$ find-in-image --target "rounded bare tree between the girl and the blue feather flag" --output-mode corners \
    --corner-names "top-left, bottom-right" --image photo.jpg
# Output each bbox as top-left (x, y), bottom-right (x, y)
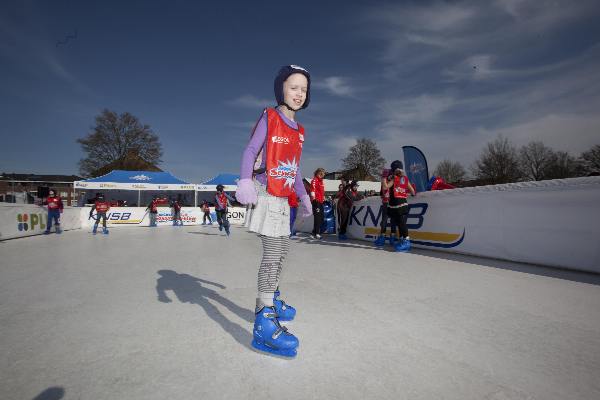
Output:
top-left (342, 138), bottom-right (385, 180)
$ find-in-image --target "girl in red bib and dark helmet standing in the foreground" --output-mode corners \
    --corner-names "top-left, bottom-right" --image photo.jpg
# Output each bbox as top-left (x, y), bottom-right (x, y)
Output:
top-left (236, 65), bottom-right (312, 357)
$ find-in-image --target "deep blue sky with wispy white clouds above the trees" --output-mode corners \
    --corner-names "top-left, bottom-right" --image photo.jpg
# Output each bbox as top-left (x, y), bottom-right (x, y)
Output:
top-left (0, 0), bottom-right (600, 182)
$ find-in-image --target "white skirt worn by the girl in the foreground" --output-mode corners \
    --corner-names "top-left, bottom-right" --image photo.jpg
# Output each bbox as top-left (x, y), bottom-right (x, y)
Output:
top-left (248, 181), bottom-right (290, 237)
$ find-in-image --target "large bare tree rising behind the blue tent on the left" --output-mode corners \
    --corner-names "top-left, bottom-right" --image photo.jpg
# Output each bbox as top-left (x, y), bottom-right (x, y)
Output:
top-left (77, 109), bottom-right (162, 176)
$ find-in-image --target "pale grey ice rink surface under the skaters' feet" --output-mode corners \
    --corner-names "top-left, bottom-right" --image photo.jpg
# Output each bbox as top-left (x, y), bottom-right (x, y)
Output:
top-left (0, 226), bottom-right (600, 400)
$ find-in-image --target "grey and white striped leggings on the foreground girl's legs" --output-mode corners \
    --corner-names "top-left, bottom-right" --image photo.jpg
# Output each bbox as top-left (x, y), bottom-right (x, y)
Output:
top-left (258, 235), bottom-right (290, 299)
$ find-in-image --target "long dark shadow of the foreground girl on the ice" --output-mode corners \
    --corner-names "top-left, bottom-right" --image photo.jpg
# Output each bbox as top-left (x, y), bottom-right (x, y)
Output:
top-left (156, 269), bottom-right (254, 349)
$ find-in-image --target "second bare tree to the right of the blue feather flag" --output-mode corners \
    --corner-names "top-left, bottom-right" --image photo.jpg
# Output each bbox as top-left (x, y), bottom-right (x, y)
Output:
top-left (471, 136), bottom-right (521, 184)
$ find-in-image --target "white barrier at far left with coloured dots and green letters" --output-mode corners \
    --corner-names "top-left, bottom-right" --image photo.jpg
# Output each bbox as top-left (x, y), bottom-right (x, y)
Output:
top-left (0, 203), bottom-right (81, 240)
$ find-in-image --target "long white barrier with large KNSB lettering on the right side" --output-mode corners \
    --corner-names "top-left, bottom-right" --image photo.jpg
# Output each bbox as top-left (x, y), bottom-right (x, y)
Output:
top-left (297, 177), bottom-right (600, 273)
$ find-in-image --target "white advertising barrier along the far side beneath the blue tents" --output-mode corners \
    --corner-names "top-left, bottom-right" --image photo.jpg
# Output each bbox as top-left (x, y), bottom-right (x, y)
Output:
top-left (80, 206), bottom-right (246, 228)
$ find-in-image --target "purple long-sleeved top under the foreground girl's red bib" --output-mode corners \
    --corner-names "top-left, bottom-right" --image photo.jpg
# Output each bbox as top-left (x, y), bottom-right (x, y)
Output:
top-left (240, 110), bottom-right (306, 198)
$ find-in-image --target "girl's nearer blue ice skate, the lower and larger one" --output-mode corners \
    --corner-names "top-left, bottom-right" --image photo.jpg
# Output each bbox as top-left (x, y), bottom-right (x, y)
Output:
top-left (252, 307), bottom-right (299, 358)
